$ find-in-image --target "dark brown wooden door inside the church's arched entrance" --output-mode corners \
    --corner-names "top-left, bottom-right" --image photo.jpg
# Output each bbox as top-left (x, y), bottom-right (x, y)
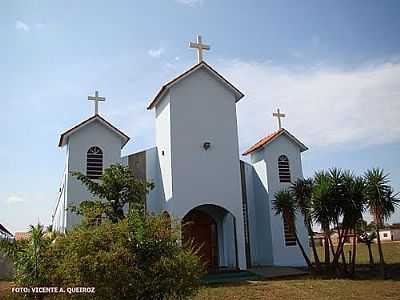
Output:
top-left (183, 210), bottom-right (218, 268)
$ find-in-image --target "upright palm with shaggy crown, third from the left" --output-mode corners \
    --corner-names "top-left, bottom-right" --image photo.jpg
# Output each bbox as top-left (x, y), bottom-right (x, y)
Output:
top-left (311, 171), bottom-right (334, 265)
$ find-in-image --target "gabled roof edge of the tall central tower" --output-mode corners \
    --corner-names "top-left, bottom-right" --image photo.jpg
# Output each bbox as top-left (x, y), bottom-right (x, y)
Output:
top-left (147, 61), bottom-right (244, 109)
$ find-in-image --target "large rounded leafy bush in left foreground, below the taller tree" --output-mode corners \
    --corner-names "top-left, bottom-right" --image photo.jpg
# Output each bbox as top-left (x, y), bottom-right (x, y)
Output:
top-left (47, 211), bottom-right (203, 299)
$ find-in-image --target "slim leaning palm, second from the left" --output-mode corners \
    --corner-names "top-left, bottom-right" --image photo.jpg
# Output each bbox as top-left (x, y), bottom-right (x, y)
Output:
top-left (290, 178), bottom-right (321, 271)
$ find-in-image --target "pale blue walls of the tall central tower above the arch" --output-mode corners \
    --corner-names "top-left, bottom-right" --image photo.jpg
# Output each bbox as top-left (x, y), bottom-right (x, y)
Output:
top-left (156, 69), bottom-right (246, 269)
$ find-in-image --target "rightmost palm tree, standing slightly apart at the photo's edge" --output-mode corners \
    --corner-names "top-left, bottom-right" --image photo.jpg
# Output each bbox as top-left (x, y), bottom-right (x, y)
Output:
top-left (364, 168), bottom-right (399, 279)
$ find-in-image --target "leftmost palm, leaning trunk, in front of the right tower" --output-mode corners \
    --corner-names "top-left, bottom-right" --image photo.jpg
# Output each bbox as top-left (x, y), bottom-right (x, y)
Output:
top-left (272, 190), bottom-right (314, 271)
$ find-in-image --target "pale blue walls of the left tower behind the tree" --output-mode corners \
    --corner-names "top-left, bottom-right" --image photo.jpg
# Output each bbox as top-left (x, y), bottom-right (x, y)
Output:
top-left (65, 121), bottom-right (122, 228)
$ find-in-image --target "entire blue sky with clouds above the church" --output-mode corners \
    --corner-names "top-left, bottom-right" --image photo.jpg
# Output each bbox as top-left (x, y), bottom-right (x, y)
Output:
top-left (0, 0), bottom-right (400, 231)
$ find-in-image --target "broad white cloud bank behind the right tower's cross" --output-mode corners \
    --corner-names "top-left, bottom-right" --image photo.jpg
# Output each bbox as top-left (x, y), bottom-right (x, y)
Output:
top-left (219, 61), bottom-right (400, 149)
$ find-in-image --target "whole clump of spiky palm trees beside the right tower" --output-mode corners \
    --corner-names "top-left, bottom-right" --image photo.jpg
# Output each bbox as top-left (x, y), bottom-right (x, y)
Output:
top-left (273, 168), bottom-right (399, 278)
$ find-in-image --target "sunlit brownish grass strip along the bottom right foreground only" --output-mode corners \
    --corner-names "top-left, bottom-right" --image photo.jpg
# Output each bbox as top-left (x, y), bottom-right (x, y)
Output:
top-left (195, 278), bottom-right (400, 300)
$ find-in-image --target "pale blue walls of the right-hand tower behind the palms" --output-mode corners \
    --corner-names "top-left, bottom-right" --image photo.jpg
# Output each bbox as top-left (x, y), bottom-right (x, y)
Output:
top-left (252, 135), bottom-right (309, 266)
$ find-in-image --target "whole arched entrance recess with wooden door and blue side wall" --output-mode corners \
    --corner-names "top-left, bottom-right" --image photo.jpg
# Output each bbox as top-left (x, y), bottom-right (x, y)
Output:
top-left (182, 204), bottom-right (238, 271)
